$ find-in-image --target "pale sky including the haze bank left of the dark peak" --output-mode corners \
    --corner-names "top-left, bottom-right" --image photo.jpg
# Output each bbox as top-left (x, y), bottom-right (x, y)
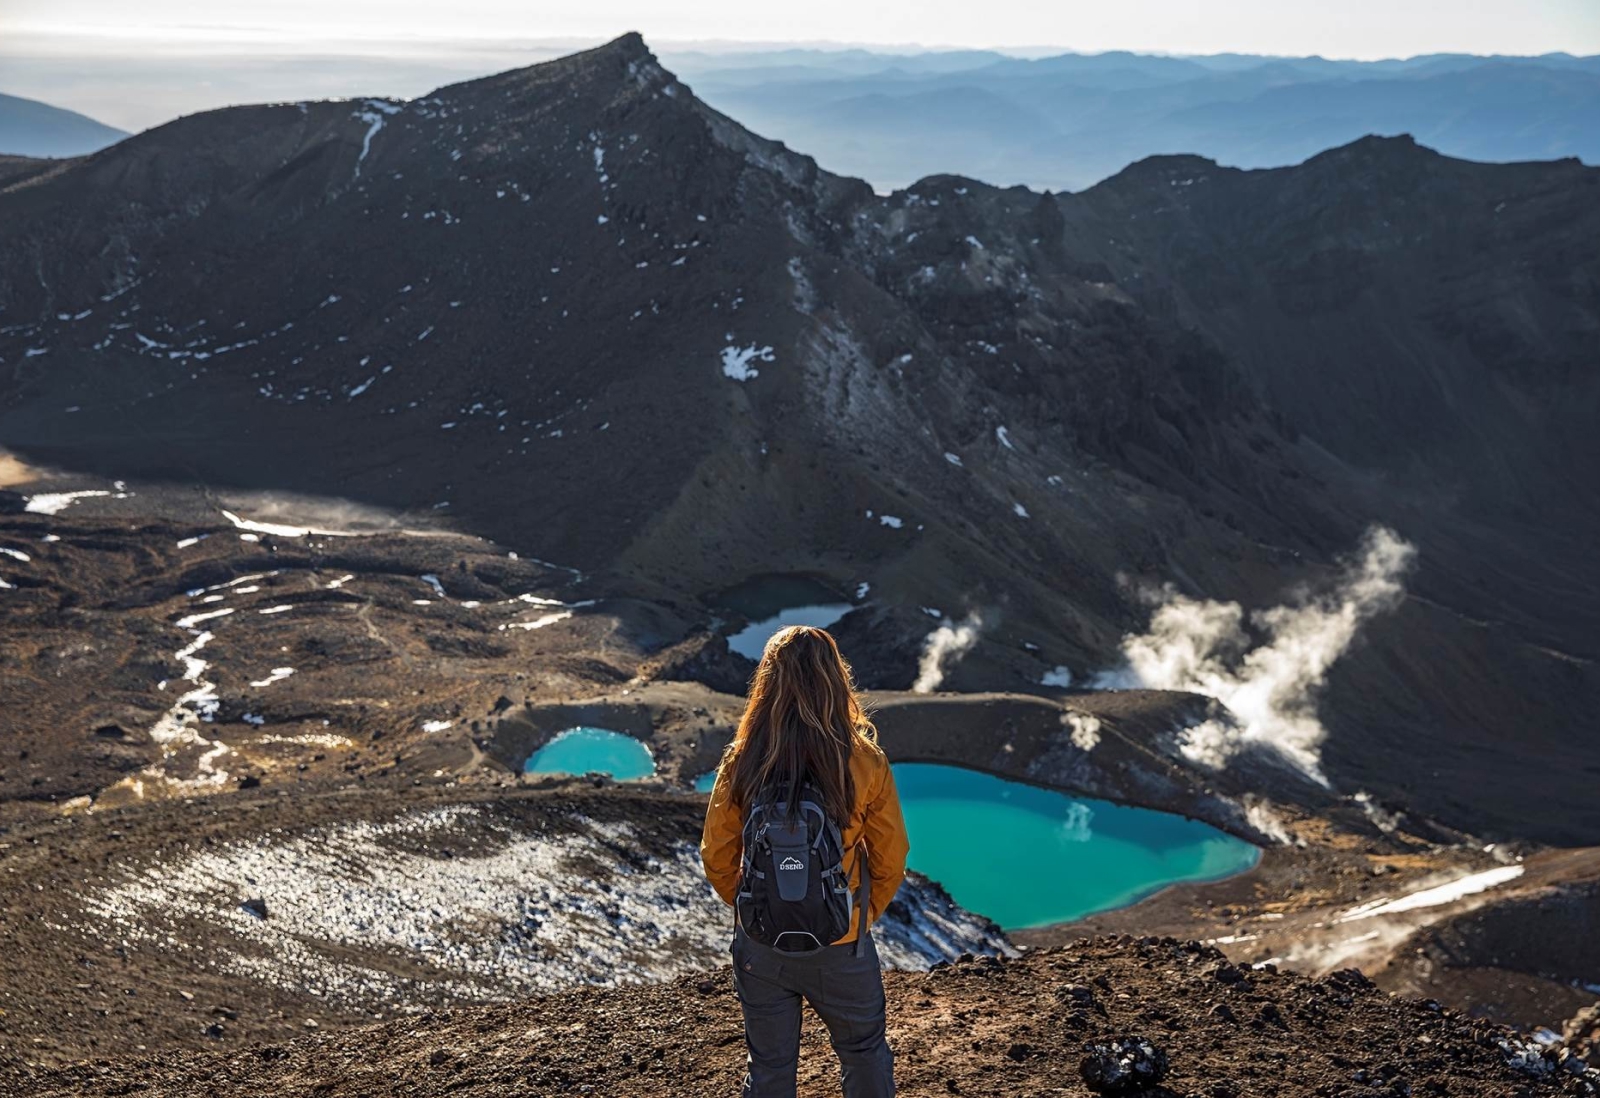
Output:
top-left (0, 0), bottom-right (1600, 128)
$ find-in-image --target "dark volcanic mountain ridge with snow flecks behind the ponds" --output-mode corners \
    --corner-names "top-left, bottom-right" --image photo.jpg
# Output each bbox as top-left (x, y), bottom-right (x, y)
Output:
top-left (0, 35), bottom-right (1600, 842)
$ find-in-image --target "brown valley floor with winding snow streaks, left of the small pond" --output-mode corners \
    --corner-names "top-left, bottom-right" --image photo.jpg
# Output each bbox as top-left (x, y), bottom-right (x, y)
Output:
top-left (0, 482), bottom-right (668, 811)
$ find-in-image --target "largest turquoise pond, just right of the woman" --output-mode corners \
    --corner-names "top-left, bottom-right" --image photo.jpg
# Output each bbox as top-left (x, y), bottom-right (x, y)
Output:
top-left (894, 762), bottom-right (1261, 930)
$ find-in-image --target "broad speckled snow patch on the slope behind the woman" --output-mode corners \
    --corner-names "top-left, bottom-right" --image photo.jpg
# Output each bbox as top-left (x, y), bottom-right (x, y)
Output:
top-left (78, 805), bottom-right (1016, 1015)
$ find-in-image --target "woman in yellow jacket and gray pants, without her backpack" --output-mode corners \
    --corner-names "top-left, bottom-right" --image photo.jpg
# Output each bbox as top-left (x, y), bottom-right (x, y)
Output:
top-left (701, 626), bottom-right (909, 1098)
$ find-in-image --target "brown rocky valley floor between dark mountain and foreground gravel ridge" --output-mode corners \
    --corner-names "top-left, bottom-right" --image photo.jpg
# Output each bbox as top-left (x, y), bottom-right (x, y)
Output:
top-left (0, 483), bottom-right (1600, 1066)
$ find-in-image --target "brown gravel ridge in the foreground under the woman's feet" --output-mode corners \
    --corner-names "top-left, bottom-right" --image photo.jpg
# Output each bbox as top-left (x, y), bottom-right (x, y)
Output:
top-left (0, 936), bottom-right (1600, 1098)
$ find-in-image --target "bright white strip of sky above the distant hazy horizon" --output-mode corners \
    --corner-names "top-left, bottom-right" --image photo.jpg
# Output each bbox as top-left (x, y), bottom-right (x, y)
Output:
top-left (15, 0), bottom-right (1600, 58)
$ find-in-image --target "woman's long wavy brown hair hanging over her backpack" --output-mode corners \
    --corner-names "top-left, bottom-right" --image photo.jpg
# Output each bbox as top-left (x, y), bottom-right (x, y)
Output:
top-left (722, 626), bottom-right (878, 828)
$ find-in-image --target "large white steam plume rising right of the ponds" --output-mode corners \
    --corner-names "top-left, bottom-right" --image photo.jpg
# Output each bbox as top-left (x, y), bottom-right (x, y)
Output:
top-left (1101, 527), bottom-right (1416, 786)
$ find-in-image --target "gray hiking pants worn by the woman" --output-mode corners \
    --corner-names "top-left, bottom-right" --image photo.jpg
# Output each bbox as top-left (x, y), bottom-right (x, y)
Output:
top-left (733, 928), bottom-right (894, 1098)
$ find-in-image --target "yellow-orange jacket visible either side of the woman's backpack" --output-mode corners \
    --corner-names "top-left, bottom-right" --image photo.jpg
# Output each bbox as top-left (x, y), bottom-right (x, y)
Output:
top-left (701, 744), bottom-right (910, 946)
